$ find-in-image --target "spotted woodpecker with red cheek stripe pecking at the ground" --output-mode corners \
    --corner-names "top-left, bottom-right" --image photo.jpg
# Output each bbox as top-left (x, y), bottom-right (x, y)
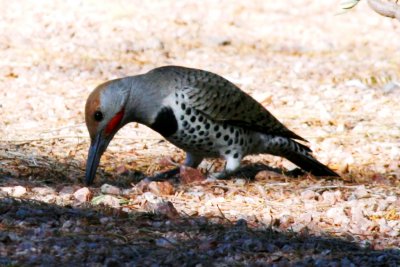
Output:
top-left (85, 66), bottom-right (339, 185)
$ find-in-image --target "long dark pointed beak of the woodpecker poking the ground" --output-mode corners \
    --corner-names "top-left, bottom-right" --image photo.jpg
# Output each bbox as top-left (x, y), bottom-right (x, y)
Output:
top-left (85, 132), bottom-right (112, 185)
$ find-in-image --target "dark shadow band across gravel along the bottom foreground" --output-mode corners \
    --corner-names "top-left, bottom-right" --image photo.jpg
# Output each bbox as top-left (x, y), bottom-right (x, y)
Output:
top-left (0, 198), bottom-right (400, 266)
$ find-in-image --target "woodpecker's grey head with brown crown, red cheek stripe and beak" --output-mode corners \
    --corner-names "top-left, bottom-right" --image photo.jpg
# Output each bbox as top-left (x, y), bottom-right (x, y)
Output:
top-left (85, 79), bottom-right (129, 185)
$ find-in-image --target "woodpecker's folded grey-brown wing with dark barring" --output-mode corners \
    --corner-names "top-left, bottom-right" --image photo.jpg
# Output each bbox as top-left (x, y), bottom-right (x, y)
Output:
top-left (176, 71), bottom-right (306, 141)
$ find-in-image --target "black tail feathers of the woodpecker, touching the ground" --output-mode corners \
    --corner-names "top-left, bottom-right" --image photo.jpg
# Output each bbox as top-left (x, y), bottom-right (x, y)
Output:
top-left (285, 152), bottom-right (340, 177)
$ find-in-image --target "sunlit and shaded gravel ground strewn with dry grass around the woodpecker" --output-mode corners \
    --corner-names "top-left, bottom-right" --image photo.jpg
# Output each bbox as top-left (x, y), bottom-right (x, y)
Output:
top-left (0, 0), bottom-right (400, 266)
